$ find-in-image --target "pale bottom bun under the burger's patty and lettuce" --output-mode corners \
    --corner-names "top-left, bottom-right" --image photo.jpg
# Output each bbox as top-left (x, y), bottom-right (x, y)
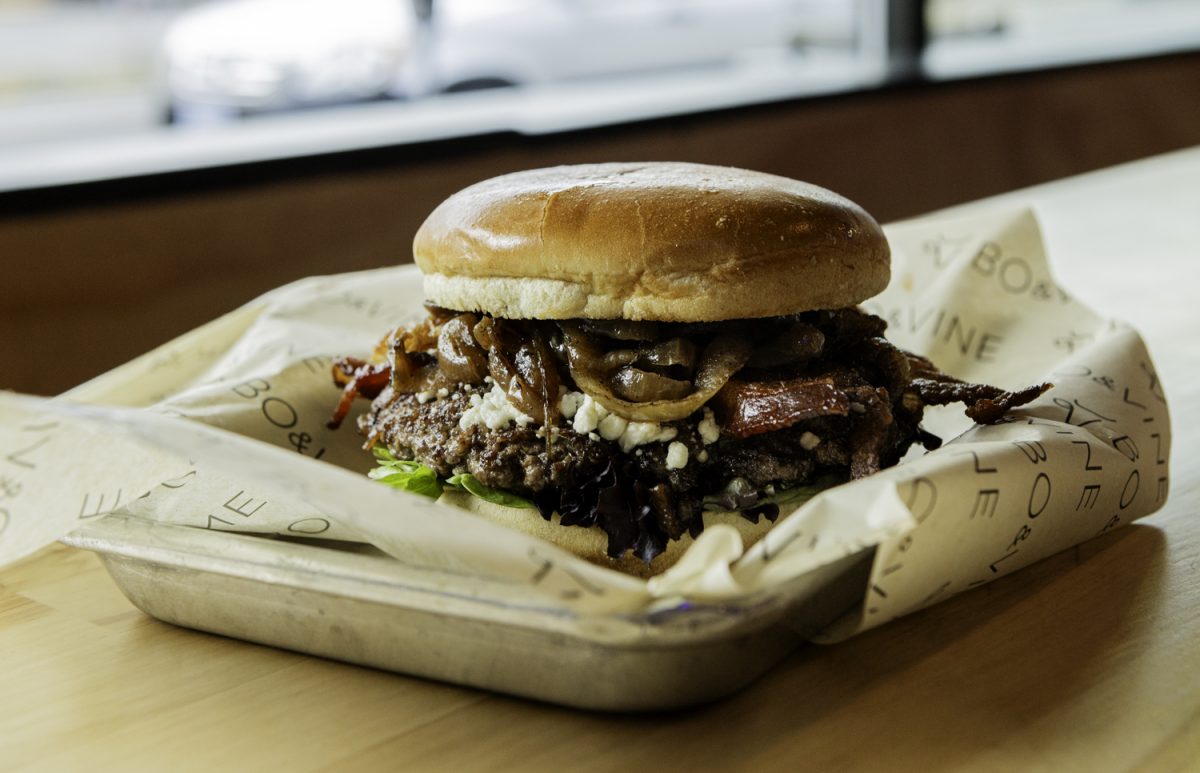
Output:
top-left (439, 491), bottom-right (796, 577)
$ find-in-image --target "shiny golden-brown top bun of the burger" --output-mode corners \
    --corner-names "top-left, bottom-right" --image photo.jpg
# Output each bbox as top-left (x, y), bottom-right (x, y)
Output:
top-left (413, 162), bottom-right (890, 322)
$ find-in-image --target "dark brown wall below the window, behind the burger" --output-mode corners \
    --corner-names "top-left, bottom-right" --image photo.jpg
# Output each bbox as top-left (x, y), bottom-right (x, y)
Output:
top-left (0, 55), bottom-right (1200, 394)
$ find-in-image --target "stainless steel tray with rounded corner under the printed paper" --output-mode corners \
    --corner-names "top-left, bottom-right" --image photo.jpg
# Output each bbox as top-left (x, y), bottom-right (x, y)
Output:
top-left (64, 515), bottom-right (871, 711)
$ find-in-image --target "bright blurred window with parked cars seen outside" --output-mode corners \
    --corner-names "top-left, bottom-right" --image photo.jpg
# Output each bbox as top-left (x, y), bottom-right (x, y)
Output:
top-left (0, 0), bottom-right (1200, 191)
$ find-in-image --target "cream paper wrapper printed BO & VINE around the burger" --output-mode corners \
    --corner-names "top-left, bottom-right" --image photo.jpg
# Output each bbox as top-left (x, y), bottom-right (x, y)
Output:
top-left (0, 206), bottom-right (1170, 641)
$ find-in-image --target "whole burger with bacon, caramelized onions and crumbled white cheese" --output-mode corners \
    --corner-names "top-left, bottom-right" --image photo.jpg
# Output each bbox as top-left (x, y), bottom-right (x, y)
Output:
top-left (331, 162), bottom-right (1048, 576)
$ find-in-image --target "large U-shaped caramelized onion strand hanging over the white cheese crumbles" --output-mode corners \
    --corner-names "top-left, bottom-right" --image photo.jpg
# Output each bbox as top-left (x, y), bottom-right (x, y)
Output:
top-left (562, 323), bottom-right (750, 421)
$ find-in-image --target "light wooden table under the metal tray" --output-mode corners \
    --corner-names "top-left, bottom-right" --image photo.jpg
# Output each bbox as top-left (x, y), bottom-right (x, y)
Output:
top-left (0, 149), bottom-right (1200, 771)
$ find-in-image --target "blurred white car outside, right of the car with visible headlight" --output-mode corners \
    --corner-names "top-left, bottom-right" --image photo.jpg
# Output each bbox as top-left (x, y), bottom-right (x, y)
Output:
top-left (397, 0), bottom-right (857, 95)
